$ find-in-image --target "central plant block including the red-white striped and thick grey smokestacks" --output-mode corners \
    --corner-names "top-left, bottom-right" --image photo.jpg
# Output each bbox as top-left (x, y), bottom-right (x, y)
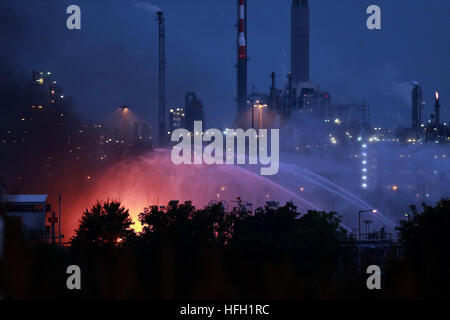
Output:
top-left (230, 0), bottom-right (370, 135)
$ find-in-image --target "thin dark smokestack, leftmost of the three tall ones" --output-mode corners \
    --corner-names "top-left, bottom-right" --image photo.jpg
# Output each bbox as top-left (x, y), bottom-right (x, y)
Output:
top-left (156, 11), bottom-right (167, 146)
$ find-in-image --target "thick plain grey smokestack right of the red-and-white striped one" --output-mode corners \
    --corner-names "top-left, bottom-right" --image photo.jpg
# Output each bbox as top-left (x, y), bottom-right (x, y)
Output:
top-left (291, 0), bottom-right (309, 86)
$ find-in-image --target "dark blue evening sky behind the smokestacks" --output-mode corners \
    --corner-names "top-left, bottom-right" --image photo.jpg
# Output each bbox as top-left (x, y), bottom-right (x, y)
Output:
top-left (4, 0), bottom-right (450, 126)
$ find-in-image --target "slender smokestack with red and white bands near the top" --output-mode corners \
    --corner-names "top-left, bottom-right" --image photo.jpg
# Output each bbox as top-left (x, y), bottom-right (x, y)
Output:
top-left (237, 0), bottom-right (247, 117)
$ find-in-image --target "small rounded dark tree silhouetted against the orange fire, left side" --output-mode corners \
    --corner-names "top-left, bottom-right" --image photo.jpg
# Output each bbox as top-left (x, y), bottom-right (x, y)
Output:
top-left (71, 201), bottom-right (135, 247)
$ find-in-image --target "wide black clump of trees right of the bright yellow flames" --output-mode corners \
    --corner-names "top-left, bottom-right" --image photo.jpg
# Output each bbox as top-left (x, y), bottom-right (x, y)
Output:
top-left (134, 202), bottom-right (354, 298)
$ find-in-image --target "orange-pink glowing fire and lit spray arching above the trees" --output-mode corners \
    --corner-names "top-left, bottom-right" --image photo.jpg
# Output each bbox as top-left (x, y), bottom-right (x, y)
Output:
top-left (58, 151), bottom-right (298, 239)
